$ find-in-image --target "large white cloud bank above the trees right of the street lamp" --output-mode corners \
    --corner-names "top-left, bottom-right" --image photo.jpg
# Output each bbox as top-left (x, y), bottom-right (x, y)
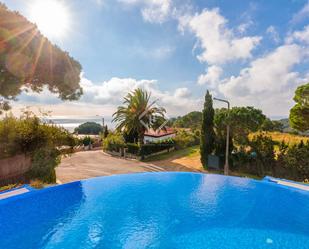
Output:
top-left (219, 44), bottom-right (303, 115)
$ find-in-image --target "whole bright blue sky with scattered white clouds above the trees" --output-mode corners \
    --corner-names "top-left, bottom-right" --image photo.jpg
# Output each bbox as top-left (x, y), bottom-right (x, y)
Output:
top-left (1, 0), bottom-right (309, 118)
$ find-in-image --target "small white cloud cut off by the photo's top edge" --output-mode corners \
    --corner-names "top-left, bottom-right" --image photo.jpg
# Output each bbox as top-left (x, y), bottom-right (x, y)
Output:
top-left (118, 0), bottom-right (172, 23)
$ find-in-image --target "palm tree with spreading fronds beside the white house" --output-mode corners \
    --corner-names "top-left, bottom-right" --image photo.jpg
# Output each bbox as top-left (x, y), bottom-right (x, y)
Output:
top-left (112, 88), bottom-right (166, 144)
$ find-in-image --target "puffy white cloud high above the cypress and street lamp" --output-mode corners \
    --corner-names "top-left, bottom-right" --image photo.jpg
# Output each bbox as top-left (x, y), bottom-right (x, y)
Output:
top-left (179, 8), bottom-right (262, 64)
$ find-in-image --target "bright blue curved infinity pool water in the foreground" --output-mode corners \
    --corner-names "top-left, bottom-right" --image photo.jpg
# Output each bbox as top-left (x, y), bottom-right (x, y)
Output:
top-left (0, 173), bottom-right (309, 249)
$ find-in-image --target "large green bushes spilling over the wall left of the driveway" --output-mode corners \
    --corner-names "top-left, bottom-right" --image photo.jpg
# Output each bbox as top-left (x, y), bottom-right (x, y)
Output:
top-left (0, 112), bottom-right (75, 182)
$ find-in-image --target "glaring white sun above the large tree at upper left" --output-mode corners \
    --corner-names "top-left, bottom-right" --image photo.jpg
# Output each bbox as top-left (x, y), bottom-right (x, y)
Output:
top-left (29, 0), bottom-right (70, 38)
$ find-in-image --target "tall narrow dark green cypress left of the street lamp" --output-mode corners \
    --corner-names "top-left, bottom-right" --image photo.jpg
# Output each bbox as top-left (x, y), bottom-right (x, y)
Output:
top-left (200, 91), bottom-right (215, 168)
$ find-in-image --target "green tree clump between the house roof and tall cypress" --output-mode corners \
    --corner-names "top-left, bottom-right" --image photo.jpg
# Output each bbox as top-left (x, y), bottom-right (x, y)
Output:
top-left (169, 111), bottom-right (202, 130)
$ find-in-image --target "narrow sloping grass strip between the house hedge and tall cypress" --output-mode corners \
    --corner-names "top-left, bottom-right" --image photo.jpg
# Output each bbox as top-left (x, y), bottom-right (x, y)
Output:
top-left (143, 145), bottom-right (200, 162)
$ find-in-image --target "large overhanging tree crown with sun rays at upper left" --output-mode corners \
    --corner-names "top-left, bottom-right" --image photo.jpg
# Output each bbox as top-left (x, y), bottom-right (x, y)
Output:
top-left (0, 3), bottom-right (82, 111)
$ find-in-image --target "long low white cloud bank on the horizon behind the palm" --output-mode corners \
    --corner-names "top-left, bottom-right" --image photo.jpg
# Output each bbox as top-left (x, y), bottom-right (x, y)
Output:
top-left (13, 75), bottom-right (201, 116)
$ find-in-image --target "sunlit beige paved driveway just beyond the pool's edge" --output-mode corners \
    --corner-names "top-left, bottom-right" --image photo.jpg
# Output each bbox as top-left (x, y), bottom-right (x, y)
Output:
top-left (56, 151), bottom-right (200, 183)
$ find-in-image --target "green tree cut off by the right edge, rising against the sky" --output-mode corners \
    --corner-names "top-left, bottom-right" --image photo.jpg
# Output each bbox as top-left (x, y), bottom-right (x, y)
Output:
top-left (289, 83), bottom-right (309, 131)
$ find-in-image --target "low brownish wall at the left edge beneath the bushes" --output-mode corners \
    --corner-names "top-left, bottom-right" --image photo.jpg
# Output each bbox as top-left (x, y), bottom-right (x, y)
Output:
top-left (0, 155), bottom-right (31, 186)
